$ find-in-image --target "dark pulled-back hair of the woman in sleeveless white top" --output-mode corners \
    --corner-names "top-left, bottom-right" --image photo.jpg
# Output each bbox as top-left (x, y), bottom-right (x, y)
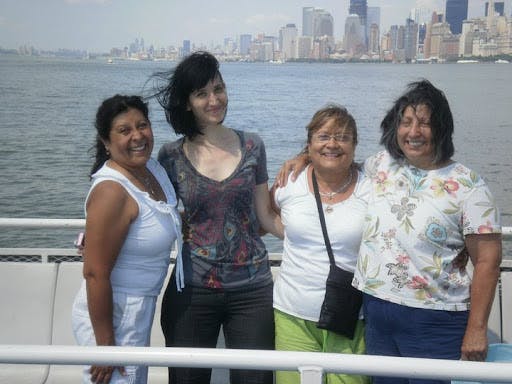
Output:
top-left (89, 95), bottom-right (149, 177)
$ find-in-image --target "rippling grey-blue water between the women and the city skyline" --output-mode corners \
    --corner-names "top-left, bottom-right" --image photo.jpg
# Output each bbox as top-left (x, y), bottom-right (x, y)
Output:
top-left (0, 56), bottom-right (512, 255)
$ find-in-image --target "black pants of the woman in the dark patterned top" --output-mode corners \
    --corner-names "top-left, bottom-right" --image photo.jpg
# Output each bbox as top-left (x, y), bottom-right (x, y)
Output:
top-left (160, 274), bottom-right (274, 384)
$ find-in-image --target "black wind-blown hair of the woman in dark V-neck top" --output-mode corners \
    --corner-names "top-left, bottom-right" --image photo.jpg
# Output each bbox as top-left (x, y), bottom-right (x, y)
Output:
top-left (152, 51), bottom-right (224, 139)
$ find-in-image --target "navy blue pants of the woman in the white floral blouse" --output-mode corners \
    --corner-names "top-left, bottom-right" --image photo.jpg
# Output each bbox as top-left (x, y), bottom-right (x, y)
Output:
top-left (363, 294), bottom-right (469, 384)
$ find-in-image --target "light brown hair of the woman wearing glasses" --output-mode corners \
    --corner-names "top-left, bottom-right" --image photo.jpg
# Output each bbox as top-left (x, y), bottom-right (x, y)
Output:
top-left (306, 103), bottom-right (357, 145)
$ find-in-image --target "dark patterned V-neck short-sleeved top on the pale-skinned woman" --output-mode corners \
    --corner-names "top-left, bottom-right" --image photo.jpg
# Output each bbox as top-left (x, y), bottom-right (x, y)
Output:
top-left (158, 130), bottom-right (272, 290)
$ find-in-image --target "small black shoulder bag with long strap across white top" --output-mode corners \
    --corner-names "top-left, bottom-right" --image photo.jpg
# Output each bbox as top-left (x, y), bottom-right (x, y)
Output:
top-left (311, 170), bottom-right (363, 339)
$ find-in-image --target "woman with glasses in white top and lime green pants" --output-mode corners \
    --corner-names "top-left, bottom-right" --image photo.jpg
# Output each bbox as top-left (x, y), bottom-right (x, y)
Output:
top-left (274, 105), bottom-right (369, 384)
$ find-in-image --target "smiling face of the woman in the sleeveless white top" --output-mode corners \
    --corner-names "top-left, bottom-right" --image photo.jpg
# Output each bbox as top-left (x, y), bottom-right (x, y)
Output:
top-left (105, 108), bottom-right (154, 169)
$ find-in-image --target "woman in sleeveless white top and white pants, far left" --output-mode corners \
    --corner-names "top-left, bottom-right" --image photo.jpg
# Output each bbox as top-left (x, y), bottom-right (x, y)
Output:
top-left (72, 95), bottom-right (181, 384)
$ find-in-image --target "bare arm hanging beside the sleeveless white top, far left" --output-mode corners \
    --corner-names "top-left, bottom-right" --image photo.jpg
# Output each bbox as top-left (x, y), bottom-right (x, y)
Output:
top-left (84, 181), bottom-right (138, 383)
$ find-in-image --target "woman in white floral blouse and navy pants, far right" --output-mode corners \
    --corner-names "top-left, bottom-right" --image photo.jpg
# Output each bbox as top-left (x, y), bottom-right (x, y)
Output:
top-left (354, 80), bottom-right (501, 384)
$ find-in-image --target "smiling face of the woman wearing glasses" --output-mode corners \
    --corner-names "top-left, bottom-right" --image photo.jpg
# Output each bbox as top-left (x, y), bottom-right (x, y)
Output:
top-left (308, 118), bottom-right (356, 172)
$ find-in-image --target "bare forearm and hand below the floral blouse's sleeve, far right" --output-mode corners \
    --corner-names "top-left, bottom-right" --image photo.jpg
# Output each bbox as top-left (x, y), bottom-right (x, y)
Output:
top-left (461, 234), bottom-right (501, 361)
